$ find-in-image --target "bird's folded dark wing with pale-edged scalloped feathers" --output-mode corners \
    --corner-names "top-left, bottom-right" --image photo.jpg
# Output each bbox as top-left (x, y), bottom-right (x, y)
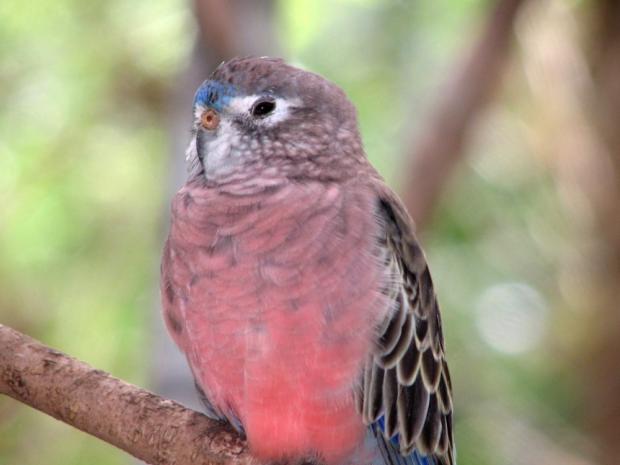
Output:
top-left (358, 188), bottom-right (455, 465)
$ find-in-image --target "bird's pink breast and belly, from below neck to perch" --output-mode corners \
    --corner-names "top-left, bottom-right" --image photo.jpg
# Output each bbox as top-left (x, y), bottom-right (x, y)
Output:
top-left (162, 180), bottom-right (386, 463)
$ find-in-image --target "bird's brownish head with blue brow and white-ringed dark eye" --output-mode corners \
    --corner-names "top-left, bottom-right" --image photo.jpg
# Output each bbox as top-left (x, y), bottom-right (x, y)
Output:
top-left (187, 57), bottom-right (364, 185)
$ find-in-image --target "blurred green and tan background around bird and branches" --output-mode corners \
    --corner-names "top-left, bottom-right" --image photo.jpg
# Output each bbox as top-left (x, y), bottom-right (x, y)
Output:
top-left (0, 0), bottom-right (620, 465)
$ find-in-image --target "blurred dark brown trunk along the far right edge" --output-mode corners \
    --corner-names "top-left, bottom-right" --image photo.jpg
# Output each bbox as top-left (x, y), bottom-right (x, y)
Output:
top-left (586, 0), bottom-right (620, 465)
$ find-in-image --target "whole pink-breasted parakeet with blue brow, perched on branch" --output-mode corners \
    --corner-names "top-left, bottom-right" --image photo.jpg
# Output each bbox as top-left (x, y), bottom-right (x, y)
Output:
top-left (160, 57), bottom-right (456, 465)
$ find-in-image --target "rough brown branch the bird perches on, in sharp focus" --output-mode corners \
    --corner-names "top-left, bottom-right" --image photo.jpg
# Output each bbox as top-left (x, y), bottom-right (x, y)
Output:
top-left (0, 325), bottom-right (255, 465)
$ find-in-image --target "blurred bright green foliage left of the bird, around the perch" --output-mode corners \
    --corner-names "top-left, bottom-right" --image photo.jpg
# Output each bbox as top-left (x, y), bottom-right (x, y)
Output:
top-left (0, 0), bottom-right (192, 464)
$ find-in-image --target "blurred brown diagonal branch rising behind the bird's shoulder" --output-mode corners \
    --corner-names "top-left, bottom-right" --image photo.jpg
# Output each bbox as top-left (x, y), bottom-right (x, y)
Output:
top-left (402, 0), bottom-right (525, 226)
